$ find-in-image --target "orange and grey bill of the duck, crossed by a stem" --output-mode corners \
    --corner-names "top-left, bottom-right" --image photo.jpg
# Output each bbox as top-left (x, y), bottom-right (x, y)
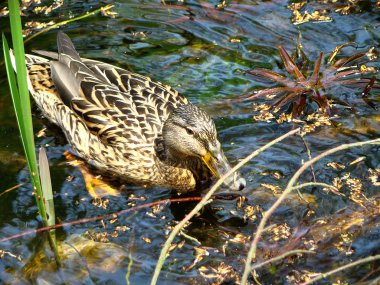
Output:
top-left (202, 150), bottom-right (246, 190)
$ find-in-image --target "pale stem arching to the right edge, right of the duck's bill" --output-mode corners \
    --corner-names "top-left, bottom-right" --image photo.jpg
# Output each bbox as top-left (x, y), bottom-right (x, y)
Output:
top-left (241, 139), bottom-right (380, 285)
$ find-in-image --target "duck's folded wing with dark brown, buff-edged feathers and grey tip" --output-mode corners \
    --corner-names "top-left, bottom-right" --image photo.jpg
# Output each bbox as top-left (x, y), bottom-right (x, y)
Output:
top-left (51, 33), bottom-right (187, 147)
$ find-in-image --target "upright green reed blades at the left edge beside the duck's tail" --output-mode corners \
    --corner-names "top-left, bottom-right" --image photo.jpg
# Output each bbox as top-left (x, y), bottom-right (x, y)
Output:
top-left (2, 1), bottom-right (57, 246)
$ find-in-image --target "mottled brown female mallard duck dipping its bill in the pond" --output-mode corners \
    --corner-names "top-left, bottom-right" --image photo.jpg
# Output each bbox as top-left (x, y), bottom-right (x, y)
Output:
top-left (26, 32), bottom-right (245, 192)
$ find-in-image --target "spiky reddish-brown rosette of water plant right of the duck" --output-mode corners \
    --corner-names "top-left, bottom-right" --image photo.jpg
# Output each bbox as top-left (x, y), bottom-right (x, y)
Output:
top-left (245, 44), bottom-right (380, 118)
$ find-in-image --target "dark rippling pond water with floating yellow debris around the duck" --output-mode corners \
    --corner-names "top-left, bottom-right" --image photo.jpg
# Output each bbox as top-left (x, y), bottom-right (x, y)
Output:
top-left (0, 0), bottom-right (380, 284)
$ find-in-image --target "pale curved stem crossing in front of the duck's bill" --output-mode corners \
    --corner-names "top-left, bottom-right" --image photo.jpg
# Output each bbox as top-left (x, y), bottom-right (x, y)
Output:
top-left (150, 128), bottom-right (300, 285)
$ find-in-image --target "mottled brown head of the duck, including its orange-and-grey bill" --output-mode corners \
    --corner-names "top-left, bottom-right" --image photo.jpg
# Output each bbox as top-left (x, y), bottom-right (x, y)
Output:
top-left (162, 104), bottom-right (246, 190)
